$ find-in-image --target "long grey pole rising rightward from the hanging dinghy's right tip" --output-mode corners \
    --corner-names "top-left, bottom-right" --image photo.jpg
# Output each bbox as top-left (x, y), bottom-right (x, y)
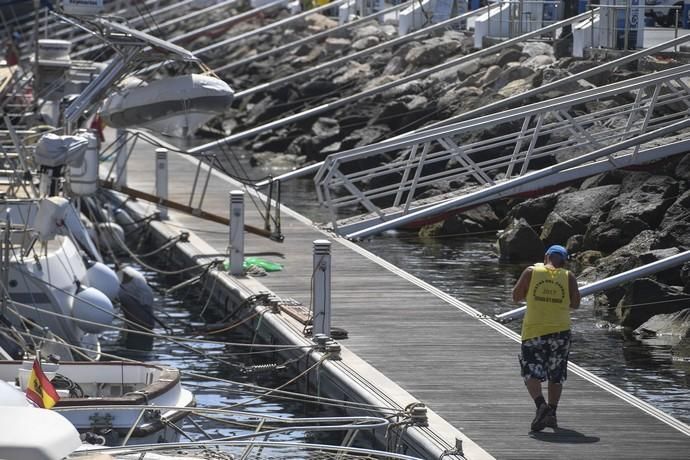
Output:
top-left (235, 6), bottom-right (488, 99)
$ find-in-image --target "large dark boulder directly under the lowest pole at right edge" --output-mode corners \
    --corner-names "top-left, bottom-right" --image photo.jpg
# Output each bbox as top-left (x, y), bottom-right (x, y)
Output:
top-left (616, 278), bottom-right (690, 329)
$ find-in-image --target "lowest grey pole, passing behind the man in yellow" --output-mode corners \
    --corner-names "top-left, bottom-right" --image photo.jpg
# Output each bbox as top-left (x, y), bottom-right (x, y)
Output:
top-left (494, 251), bottom-right (690, 323)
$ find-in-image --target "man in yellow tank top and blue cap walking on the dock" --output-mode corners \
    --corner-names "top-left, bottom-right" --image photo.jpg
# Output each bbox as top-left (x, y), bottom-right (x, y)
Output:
top-left (513, 245), bottom-right (580, 431)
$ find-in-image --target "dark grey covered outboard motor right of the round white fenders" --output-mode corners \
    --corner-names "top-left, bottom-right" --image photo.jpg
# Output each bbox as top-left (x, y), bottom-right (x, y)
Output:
top-left (118, 267), bottom-right (155, 350)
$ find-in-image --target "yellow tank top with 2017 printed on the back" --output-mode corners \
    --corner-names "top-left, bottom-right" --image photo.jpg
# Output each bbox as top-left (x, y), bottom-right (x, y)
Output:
top-left (522, 264), bottom-right (570, 340)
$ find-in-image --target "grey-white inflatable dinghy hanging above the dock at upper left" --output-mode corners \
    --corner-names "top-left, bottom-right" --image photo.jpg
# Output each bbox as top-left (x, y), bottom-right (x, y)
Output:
top-left (100, 74), bottom-right (234, 137)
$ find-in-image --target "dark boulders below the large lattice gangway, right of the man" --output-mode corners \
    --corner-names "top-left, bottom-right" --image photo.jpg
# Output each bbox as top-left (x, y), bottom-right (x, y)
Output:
top-left (492, 154), bottom-right (690, 359)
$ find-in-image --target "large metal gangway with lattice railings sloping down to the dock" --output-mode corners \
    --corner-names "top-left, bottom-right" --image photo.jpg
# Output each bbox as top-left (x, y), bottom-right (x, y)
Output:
top-left (314, 65), bottom-right (690, 238)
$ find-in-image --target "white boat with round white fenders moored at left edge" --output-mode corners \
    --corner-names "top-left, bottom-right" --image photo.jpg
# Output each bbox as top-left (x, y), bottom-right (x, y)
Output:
top-left (0, 200), bottom-right (117, 359)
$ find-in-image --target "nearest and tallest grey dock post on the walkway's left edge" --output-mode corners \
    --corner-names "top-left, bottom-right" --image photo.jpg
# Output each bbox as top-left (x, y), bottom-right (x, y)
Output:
top-left (312, 240), bottom-right (331, 338)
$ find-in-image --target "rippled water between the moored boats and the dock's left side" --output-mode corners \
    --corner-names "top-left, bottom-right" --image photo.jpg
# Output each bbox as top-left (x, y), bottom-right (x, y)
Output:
top-left (102, 261), bottom-right (346, 450)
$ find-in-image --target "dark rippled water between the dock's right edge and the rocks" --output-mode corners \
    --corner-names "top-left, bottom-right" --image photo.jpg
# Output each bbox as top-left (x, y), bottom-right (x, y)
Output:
top-left (270, 175), bottom-right (690, 423)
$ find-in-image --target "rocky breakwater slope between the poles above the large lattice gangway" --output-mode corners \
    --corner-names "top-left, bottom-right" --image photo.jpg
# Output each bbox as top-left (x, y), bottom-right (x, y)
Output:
top-left (200, 14), bottom-right (608, 166)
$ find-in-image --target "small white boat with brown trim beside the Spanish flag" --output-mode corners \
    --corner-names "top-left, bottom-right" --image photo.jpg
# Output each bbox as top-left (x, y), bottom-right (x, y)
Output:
top-left (0, 361), bottom-right (195, 445)
